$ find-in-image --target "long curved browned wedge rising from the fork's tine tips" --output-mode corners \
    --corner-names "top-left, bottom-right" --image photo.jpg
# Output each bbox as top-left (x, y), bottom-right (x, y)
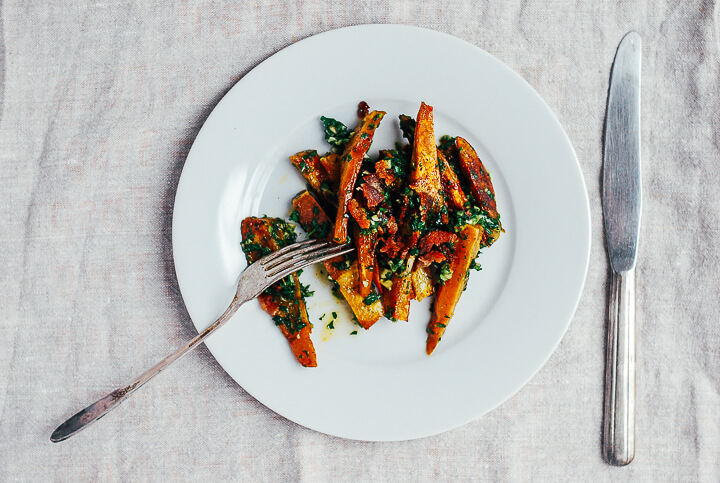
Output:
top-left (333, 111), bottom-right (385, 243)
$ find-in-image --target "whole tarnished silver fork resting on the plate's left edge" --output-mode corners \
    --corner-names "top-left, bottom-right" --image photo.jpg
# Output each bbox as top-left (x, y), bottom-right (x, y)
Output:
top-left (50, 240), bottom-right (353, 443)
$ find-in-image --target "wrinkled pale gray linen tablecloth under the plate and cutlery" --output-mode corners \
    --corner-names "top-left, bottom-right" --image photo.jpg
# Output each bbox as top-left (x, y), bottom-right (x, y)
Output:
top-left (0, 0), bottom-right (720, 481)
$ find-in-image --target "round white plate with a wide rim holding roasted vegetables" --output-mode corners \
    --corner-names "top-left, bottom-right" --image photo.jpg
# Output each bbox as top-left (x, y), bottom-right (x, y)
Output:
top-left (173, 25), bottom-right (590, 441)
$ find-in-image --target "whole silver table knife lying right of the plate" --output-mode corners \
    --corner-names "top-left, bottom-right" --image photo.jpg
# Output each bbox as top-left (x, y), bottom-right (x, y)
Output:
top-left (603, 32), bottom-right (642, 466)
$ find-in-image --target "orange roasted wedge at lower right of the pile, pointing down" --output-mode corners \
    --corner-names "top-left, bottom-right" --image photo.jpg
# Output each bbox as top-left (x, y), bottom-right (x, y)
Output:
top-left (425, 225), bottom-right (483, 355)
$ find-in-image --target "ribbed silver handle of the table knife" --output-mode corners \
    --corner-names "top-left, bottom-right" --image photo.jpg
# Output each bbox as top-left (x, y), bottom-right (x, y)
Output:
top-left (603, 268), bottom-right (635, 466)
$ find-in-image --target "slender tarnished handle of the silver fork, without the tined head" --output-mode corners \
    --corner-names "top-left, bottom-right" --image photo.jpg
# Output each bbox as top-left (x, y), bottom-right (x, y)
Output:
top-left (50, 294), bottom-right (245, 443)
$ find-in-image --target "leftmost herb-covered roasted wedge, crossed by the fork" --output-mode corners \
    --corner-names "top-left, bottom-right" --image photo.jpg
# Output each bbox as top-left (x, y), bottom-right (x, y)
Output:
top-left (241, 217), bottom-right (317, 367)
